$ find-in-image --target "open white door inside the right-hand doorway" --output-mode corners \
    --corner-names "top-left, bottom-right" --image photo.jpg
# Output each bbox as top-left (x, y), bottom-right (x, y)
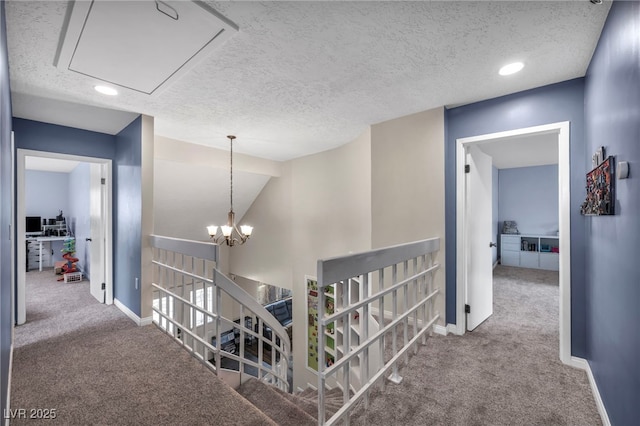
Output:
top-left (465, 145), bottom-right (493, 330)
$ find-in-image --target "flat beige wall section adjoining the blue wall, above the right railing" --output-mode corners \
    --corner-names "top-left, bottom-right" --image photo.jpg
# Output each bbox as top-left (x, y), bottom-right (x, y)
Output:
top-left (371, 108), bottom-right (445, 325)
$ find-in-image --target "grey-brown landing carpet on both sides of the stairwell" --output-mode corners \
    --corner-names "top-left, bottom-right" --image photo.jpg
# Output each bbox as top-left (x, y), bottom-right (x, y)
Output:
top-left (11, 266), bottom-right (601, 426)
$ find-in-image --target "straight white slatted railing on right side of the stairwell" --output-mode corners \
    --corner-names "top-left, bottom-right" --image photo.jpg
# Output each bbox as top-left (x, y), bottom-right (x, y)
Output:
top-left (318, 238), bottom-right (440, 425)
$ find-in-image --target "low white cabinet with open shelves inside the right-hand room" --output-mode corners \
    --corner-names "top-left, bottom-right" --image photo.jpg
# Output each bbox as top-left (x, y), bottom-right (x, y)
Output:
top-left (500, 234), bottom-right (560, 271)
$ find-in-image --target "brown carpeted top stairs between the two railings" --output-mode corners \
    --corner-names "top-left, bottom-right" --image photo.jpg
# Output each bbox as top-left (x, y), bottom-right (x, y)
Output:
top-left (238, 379), bottom-right (343, 426)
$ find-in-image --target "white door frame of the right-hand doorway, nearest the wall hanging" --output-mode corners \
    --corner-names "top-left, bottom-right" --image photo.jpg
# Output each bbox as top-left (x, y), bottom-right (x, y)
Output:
top-left (454, 121), bottom-right (571, 364)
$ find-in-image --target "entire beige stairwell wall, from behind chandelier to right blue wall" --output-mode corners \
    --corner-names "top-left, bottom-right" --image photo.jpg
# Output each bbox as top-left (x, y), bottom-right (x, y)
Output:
top-left (154, 108), bottom-right (445, 387)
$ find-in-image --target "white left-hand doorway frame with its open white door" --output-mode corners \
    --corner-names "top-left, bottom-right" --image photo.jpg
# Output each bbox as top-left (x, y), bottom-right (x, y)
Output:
top-left (15, 149), bottom-right (113, 325)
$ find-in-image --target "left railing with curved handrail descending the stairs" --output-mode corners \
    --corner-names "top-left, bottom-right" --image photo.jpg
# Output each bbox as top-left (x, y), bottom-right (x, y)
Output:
top-left (149, 234), bottom-right (291, 391)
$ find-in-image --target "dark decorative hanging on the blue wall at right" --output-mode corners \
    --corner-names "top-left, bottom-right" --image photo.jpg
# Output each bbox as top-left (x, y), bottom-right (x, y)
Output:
top-left (580, 156), bottom-right (616, 216)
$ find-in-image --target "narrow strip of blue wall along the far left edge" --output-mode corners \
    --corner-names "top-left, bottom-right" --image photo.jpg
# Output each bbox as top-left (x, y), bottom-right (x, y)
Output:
top-left (0, 1), bottom-right (13, 413)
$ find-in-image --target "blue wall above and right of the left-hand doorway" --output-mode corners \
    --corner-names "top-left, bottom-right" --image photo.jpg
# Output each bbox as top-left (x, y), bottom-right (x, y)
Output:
top-left (13, 117), bottom-right (142, 315)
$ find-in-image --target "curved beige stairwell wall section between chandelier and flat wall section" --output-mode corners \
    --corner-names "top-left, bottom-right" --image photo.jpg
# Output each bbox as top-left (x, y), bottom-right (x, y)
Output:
top-left (230, 130), bottom-right (371, 386)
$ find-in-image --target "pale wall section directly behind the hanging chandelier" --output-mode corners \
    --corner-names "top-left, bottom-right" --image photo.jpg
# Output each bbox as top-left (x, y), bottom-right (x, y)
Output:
top-left (153, 136), bottom-right (282, 273)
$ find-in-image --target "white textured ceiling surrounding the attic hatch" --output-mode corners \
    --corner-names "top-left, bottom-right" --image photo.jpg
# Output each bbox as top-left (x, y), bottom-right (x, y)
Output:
top-left (6, 0), bottom-right (610, 160)
